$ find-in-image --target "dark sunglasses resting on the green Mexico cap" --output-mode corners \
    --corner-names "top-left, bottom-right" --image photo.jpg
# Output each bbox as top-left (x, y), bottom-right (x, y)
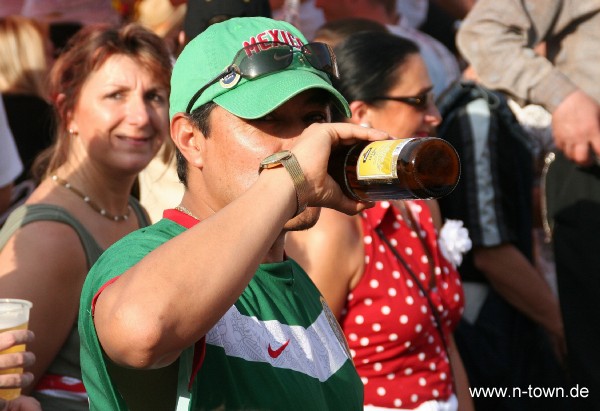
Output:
top-left (185, 41), bottom-right (339, 114)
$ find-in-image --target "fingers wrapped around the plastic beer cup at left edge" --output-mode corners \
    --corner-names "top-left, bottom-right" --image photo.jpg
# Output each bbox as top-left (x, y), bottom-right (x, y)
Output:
top-left (0, 330), bottom-right (42, 411)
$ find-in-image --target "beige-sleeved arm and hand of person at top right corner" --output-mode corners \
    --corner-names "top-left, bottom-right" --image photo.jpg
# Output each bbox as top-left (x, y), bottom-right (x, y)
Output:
top-left (456, 0), bottom-right (600, 165)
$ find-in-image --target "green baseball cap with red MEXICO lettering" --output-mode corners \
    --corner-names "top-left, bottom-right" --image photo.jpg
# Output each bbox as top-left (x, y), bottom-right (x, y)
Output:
top-left (169, 17), bottom-right (351, 119)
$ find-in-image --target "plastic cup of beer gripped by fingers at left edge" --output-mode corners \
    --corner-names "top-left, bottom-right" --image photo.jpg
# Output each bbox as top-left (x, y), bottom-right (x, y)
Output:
top-left (0, 298), bottom-right (32, 400)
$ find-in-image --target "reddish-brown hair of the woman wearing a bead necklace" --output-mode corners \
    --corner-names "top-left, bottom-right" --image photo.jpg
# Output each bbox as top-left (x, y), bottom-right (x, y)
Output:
top-left (33, 23), bottom-right (172, 180)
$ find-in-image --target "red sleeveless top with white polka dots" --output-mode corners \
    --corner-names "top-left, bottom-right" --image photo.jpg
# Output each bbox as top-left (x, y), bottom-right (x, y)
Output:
top-left (341, 200), bottom-right (463, 409)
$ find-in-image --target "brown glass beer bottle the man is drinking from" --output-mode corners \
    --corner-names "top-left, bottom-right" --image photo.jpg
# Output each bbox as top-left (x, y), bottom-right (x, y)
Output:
top-left (328, 137), bottom-right (460, 201)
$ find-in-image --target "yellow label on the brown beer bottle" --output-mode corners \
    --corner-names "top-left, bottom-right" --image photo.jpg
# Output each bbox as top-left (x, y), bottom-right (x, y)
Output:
top-left (356, 138), bottom-right (413, 181)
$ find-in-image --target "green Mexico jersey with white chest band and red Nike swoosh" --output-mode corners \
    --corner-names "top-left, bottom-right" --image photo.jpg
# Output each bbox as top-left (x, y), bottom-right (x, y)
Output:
top-left (80, 210), bottom-right (363, 411)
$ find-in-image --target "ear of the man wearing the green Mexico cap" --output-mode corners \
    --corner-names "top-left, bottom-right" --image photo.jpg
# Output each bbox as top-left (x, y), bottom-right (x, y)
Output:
top-left (171, 113), bottom-right (206, 168)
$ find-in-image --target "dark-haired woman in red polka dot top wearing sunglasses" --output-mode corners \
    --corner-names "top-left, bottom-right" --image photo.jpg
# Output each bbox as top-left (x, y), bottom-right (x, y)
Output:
top-left (287, 32), bottom-right (473, 411)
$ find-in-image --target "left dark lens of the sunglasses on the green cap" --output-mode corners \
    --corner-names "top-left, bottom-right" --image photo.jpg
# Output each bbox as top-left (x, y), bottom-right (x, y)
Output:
top-left (238, 44), bottom-right (294, 79)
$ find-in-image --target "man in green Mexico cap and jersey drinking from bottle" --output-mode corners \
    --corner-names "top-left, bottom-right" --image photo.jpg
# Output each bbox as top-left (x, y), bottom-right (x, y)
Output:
top-left (79, 17), bottom-right (388, 410)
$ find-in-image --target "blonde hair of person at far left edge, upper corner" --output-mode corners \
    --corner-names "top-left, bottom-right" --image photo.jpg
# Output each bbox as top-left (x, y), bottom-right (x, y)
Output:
top-left (0, 16), bottom-right (48, 98)
